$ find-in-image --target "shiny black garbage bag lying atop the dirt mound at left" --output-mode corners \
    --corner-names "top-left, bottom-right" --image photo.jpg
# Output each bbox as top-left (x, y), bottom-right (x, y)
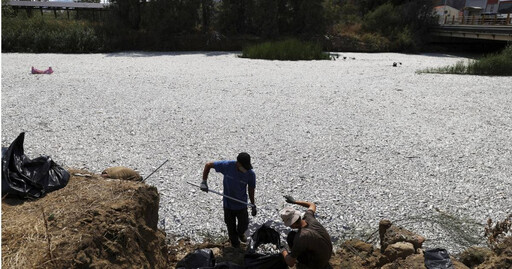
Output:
top-left (2, 133), bottom-right (70, 198)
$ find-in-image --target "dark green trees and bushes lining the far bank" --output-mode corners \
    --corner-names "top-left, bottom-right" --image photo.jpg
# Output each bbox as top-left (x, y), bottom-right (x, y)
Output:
top-left (2, 0), bottom-right (435, 53)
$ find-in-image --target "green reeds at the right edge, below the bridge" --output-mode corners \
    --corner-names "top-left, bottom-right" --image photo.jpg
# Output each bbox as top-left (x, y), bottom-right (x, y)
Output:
top-left (418, 45), bottom-right (512, 76)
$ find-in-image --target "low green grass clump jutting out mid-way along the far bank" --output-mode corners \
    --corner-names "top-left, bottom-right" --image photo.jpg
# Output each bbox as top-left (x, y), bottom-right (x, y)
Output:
top-left (240, 39), bottom-right (331, 61)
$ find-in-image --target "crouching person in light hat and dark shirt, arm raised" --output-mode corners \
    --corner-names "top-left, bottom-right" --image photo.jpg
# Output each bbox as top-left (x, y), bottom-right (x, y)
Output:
top-left (280, 196), bottom-right (332, 269)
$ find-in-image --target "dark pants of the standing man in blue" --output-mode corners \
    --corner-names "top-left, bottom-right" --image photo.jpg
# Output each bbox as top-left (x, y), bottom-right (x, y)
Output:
top-left (224, 208), bottom-right (249, 247)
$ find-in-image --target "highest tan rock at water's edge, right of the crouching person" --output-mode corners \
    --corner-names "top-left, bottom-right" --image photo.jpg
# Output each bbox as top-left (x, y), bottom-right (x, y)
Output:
top-left (379, 220), bottom-right (425, 253)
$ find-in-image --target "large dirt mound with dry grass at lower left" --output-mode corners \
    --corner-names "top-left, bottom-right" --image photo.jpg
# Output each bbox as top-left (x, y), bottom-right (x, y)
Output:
top-left (2, 170), bottom-right (168, 268)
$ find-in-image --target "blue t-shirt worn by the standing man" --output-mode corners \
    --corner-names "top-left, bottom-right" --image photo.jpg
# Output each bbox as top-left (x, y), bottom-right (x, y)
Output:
top-left (213, 161), bottom-right (256, 210)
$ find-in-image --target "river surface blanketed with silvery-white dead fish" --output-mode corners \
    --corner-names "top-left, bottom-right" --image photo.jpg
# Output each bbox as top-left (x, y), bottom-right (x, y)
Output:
top-left (1, 52), bottom-right (512, 252)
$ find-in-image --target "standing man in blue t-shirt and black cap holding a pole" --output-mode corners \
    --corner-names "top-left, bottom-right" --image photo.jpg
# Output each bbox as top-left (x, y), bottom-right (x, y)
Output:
top-left (201, 152), bottom-right (256, 248)
